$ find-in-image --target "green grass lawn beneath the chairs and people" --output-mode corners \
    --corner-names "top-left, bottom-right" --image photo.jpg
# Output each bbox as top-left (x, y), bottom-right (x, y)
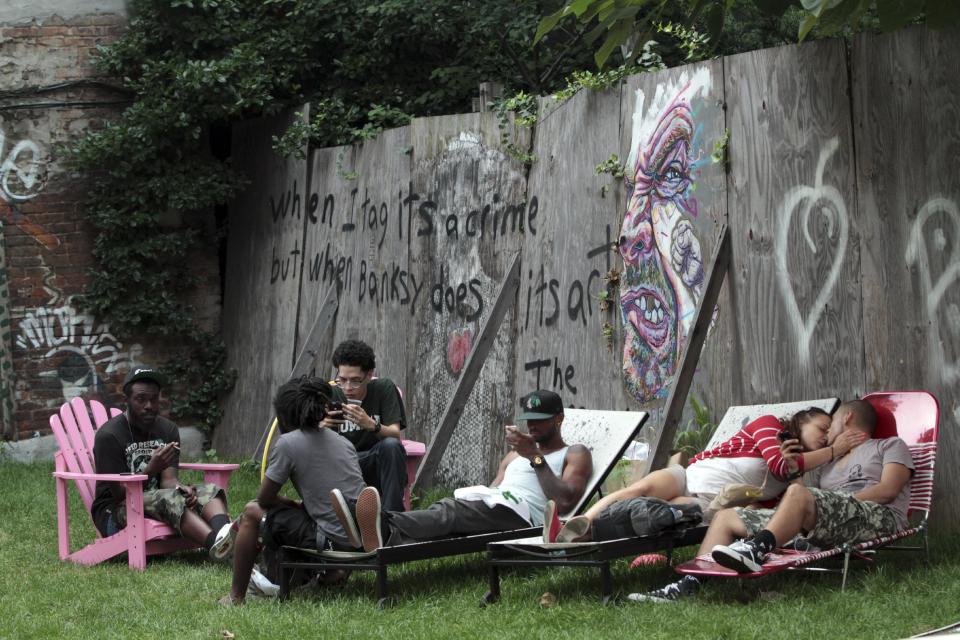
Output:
top-left (0, 463), bottom-right (960, 640)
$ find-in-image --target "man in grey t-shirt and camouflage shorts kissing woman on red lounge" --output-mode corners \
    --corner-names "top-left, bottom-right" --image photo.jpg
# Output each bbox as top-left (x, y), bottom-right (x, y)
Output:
top-left (629, 400), bottom-right (914, 602)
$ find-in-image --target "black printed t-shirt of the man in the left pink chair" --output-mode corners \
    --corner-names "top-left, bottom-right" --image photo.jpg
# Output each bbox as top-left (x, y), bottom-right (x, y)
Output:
top-left (90, 413), bottom-right (180, 533)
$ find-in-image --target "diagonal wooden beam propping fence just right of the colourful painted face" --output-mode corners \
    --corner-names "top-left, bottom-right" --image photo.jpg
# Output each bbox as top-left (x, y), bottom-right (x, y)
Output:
top-left (649, 224), bottom-right (730, 471)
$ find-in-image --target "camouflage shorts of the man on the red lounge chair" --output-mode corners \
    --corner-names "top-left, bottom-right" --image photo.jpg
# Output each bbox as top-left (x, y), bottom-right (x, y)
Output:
top-left (736, 488), bottom-right (897, 547)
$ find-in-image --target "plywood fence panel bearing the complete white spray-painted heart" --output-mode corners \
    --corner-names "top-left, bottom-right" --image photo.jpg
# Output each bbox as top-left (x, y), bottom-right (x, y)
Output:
top-left (725, 41), bottom-right (864, 402)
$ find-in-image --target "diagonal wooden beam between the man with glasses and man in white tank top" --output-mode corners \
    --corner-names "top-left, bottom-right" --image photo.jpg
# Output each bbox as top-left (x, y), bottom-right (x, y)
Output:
top-left (411, 251), bottom-right (520, 491)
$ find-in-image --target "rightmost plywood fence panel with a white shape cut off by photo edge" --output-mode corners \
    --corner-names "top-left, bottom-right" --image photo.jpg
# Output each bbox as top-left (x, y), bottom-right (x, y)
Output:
top-left (852, 28), bottom-right (960, 527)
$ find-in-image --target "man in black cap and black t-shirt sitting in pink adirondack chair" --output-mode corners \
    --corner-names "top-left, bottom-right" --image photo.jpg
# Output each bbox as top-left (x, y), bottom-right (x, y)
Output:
top-left (90, 367), bottom-right (233, 559)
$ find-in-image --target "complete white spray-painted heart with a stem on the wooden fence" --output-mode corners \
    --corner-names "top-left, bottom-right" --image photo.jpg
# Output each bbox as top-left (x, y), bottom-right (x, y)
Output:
top-left (774, 137), bottom-right (850, 368)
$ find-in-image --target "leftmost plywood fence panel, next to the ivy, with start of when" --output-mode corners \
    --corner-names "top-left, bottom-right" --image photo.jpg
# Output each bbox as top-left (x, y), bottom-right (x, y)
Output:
top-left (214, 107), bottom-right (306, 455)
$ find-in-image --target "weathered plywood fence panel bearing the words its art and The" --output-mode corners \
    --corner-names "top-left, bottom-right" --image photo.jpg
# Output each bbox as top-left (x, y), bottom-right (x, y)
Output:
top-left (514, 89), bottom-right (626, 420)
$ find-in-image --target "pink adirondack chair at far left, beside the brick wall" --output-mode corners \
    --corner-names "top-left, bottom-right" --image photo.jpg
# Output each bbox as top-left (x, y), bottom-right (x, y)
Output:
top-left (50, 398), bottom-right (240, 571)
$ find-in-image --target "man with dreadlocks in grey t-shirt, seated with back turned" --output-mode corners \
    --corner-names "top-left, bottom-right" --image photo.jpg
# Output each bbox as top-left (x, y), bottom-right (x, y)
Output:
top-left (220, 377), bottom-right (364, 606)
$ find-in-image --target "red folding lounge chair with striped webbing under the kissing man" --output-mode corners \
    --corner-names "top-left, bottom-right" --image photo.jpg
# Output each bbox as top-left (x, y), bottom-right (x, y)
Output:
top-left (676, 391), bottom-right (940, 590)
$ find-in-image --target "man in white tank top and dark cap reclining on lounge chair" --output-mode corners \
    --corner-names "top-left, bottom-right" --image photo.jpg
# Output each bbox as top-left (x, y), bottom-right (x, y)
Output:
top-left (331, 390), bottom-right (592, 552)
